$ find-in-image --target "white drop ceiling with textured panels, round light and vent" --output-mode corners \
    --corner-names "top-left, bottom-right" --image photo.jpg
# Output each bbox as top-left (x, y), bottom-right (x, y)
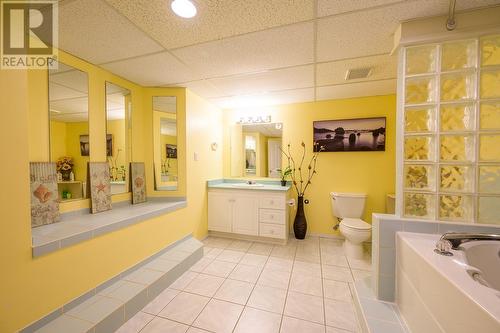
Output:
top-left (54, 0), bottom-right (500, 107)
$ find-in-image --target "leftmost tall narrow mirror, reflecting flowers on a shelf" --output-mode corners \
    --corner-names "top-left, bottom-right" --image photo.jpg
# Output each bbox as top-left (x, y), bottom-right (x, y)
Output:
top-left (49, 62), bottom-right (90, 202)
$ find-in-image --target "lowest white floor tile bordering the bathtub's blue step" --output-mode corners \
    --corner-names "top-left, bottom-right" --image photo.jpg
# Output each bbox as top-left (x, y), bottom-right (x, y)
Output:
top-left (325, 298), bottom-right (358, 332)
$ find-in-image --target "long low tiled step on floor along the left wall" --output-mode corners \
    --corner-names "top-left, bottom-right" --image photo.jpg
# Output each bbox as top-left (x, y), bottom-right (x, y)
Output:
top-left (21, 237), bottom-right (203, 333)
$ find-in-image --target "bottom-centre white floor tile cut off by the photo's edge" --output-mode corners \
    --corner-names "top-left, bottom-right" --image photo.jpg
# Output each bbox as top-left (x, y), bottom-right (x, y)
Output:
top-left (234, 307), bottom-right (281, 333)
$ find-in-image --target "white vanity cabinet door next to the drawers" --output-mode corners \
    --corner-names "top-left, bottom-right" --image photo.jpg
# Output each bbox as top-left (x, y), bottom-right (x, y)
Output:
top-left (233, 194), bottom-right (259, 236)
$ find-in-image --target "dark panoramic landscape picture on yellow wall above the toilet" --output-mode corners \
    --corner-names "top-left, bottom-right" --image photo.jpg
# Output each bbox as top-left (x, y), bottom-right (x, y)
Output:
top-left (313, 117), bottom-right (386, 152)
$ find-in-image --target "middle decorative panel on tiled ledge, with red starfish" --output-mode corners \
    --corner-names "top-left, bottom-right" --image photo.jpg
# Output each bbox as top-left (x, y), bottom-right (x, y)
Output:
top-left (87, 162), bottom-right (111, 214)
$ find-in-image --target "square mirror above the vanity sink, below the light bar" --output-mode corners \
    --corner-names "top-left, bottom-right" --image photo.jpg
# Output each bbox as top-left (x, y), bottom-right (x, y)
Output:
top-left (230, 123), bottom-right (283, 178)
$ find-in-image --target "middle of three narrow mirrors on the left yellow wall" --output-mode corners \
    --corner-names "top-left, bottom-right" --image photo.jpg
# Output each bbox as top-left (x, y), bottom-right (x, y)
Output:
top-left (106, 82), bottom-right (132, 194)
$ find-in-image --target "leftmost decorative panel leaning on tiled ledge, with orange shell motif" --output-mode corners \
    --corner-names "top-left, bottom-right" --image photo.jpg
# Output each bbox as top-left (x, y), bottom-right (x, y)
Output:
top-left (30, 162), bottom-right (60, 227)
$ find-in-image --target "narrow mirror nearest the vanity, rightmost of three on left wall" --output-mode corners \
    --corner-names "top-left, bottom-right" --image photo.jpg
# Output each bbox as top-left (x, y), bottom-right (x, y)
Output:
top-left (153, 96), bottom-right (178, 191)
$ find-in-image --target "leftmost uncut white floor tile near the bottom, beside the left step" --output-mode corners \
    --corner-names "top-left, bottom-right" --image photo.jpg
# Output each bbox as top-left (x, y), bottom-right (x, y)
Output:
top-left (159, 292), bottom-right (210, 325)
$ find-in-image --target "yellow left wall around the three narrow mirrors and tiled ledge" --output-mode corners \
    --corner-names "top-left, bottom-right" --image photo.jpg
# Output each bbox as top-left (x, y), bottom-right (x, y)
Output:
top-left (0, 51), bottom-right (222, 333)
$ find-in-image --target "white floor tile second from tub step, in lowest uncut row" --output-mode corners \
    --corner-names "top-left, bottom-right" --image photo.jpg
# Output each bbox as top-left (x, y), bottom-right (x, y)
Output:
top-left (285, 291), bottom-right (325, 324)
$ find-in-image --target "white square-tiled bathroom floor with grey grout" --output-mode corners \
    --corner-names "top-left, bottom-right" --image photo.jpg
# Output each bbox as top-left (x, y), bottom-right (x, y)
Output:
top-left (116, 237), bottom-right (371, 333)
